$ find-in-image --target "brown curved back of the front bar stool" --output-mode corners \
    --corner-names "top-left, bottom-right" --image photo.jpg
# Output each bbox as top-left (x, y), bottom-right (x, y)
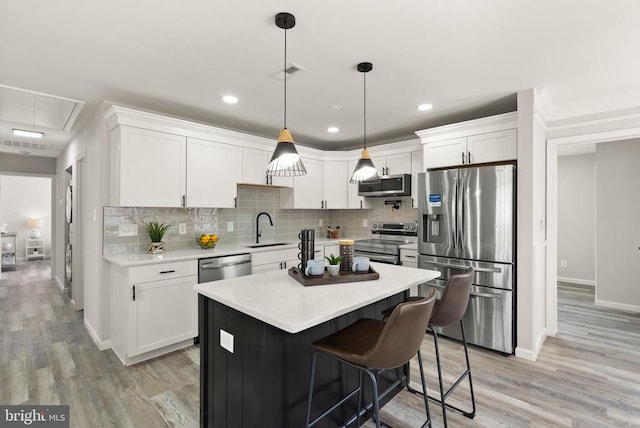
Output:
top-left (362, 290), bottom-right (436, 369)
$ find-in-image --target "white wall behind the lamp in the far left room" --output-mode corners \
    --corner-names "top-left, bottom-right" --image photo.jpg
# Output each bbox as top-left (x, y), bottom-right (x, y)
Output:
top-left (0, 175), bottom-right (51, 260)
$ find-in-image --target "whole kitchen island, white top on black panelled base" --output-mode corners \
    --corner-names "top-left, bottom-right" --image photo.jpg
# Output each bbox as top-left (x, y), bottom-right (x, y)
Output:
top-left (195, 263), bottom-right (440, 428)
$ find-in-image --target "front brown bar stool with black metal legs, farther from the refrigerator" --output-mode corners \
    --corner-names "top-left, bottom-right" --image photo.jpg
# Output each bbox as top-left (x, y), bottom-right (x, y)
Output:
top-left (306, 292), bottom-right (435, 428)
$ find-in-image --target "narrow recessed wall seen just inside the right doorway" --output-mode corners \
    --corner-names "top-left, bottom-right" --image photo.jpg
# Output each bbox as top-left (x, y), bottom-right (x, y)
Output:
top-left (557, 153), bottom-right (596, 285)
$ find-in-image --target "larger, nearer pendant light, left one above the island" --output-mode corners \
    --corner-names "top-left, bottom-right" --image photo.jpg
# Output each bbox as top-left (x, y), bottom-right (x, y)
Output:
top-left (267, 12), bottom-right (307, 176)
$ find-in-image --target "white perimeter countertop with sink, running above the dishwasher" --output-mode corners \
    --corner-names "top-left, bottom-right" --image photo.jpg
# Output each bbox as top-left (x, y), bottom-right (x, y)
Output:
top-left (103, 238), bottom-right (339, 266)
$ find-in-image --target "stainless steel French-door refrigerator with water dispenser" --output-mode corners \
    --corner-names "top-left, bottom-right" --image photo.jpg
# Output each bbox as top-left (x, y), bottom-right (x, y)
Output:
top-left (418, 164), bottom-right (516, 354)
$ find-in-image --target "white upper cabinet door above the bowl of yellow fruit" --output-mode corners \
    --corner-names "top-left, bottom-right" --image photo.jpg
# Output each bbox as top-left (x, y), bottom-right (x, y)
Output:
top-left (186, 138), bottom-right (241, 208)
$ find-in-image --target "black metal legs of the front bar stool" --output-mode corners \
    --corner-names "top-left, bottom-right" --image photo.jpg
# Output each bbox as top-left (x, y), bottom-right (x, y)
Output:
top-left (305, 351), bottom-right (431, 428)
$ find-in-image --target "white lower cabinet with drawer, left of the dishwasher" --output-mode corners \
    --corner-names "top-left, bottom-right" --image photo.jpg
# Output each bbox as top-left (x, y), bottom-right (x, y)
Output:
top-left (111, 260), bottom-right (198, 365)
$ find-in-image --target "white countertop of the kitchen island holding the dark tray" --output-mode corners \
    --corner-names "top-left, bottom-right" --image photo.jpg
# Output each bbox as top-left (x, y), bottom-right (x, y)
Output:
top-left (194, 263), bottom-right (440, 333)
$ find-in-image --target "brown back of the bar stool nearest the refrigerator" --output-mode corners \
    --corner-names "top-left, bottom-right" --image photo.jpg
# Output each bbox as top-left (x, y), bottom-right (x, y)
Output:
top-left (429, 268), bottom-right (473, 327)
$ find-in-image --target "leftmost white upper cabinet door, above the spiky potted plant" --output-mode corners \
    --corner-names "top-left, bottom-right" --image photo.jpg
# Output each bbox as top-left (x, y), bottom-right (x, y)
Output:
top-left (111, 126), bottom-right (186, 207)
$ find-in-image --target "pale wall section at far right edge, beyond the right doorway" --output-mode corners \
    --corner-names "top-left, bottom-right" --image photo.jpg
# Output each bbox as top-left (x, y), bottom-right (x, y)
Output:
top-left (595, 139), bottom-right (640, 312)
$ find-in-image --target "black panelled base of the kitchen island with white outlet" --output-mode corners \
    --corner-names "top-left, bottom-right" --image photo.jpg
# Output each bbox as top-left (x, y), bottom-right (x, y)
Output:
top-left (199, 292), bottom-right (408, 428)
